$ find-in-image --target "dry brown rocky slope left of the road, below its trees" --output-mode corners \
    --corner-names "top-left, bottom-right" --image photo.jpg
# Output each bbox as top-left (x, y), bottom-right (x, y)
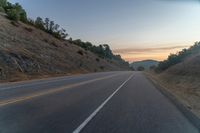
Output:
top-left (0, 13), bottom-right (129, 81)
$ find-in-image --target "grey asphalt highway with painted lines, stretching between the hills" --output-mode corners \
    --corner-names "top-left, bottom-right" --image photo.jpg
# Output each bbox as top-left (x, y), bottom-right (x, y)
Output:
top-left (0, 71), bottom-right (198, 133)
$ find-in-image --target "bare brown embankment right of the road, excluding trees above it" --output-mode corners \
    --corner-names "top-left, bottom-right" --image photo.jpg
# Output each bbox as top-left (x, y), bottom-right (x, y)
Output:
top-left (147, 55), bottom-right (200, 118)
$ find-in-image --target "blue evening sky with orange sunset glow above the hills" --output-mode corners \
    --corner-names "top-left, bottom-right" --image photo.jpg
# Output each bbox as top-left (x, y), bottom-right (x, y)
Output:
top-left (9, 0), bottom-right (200, 62)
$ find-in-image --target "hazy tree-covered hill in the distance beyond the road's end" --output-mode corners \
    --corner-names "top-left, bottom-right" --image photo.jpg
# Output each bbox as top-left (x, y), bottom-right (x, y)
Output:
top-left (130, 60), bottom-right (158, 70)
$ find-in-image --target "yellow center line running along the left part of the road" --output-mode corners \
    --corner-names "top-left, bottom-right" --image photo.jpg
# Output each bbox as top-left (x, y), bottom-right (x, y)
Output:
top-left (0, 74), bottom-right (119, 107)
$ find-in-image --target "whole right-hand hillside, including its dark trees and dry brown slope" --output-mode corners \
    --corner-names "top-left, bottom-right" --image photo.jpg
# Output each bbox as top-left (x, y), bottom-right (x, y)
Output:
top-left (147, 42), bottom-right (200, 117)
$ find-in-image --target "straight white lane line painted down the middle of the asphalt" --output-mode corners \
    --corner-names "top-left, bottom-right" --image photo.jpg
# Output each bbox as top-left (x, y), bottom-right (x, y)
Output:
top-left (73, 74), bottom-right (133, 133)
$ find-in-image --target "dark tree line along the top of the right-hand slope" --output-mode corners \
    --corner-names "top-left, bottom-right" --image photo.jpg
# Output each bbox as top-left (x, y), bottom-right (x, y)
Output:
top-left (155, 42), bottom-right (200, 72)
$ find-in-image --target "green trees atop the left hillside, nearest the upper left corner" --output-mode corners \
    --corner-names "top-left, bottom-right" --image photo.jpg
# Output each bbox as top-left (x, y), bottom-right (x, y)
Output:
top-left (0, 0), bottom-right (68, 39)
